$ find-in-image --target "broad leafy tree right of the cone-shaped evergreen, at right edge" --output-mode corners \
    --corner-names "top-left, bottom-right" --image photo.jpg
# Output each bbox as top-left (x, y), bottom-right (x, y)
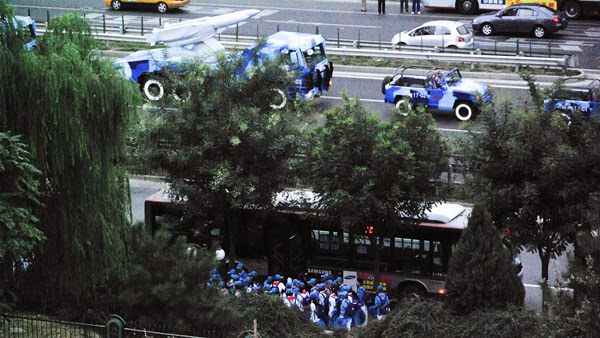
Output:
top-left (461, 75), bottom-right (600, 281)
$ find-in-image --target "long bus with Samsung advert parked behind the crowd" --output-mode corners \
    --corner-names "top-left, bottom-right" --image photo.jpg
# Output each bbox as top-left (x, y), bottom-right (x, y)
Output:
top-left (145, 190), bottom-right (482, 296)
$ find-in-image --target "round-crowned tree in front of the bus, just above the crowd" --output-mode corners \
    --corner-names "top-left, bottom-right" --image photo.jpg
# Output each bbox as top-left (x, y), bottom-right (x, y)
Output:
top-left (306, 96), bottom-right (448, 290)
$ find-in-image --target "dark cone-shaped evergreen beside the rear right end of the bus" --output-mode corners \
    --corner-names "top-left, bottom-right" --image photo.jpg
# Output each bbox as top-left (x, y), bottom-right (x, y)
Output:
top-left (446, 205), bottom-right (525, 313)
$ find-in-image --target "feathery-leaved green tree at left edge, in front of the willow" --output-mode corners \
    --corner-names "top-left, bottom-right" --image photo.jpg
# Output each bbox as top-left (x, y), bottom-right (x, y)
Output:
top-left (0, 132), bottom-right (46, 313)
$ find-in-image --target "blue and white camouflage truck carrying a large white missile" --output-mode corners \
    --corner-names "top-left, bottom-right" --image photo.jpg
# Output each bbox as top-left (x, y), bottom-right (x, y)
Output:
top-left (116, 10), bottom-right (333, 109)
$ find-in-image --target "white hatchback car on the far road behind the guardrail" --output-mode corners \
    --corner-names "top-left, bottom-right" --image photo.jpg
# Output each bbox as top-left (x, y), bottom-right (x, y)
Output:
top-left (392, 20), bottom-right (473, 48)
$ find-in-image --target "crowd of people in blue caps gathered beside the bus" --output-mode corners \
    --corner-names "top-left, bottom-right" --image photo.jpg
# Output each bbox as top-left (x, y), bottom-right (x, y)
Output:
top-left (208, 264), bottom-right (390, 330)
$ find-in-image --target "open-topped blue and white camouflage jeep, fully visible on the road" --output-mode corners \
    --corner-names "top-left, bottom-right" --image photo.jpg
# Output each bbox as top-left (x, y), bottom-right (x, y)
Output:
top-left (381, 68), bottom-right (491, 121)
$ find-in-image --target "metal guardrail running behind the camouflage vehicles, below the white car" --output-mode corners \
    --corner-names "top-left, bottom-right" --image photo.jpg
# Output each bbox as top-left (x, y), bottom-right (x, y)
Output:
top-left (38, 24), bottom-right (576, 72)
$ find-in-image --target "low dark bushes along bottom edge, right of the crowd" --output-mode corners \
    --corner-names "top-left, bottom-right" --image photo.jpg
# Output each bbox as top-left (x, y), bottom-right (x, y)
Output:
top-left (352, 300), bottom-right (568, 338)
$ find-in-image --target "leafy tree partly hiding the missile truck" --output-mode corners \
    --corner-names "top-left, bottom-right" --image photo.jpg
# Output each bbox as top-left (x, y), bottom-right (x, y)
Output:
top-left (144, 43), bottom-right (302, 270)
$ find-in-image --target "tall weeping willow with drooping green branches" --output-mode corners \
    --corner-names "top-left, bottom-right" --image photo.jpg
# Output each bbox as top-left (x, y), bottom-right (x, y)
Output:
top-left (0, 1), bottom-right (140, 299)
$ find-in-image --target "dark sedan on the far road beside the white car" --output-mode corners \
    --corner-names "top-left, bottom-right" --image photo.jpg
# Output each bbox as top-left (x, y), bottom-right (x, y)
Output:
top-left (473, 4), bottom-right (567, 39)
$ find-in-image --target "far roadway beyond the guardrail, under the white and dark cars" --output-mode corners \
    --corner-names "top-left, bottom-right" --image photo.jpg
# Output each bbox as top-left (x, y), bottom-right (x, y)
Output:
top-left (10, 0), bottom-right (600, 68)
